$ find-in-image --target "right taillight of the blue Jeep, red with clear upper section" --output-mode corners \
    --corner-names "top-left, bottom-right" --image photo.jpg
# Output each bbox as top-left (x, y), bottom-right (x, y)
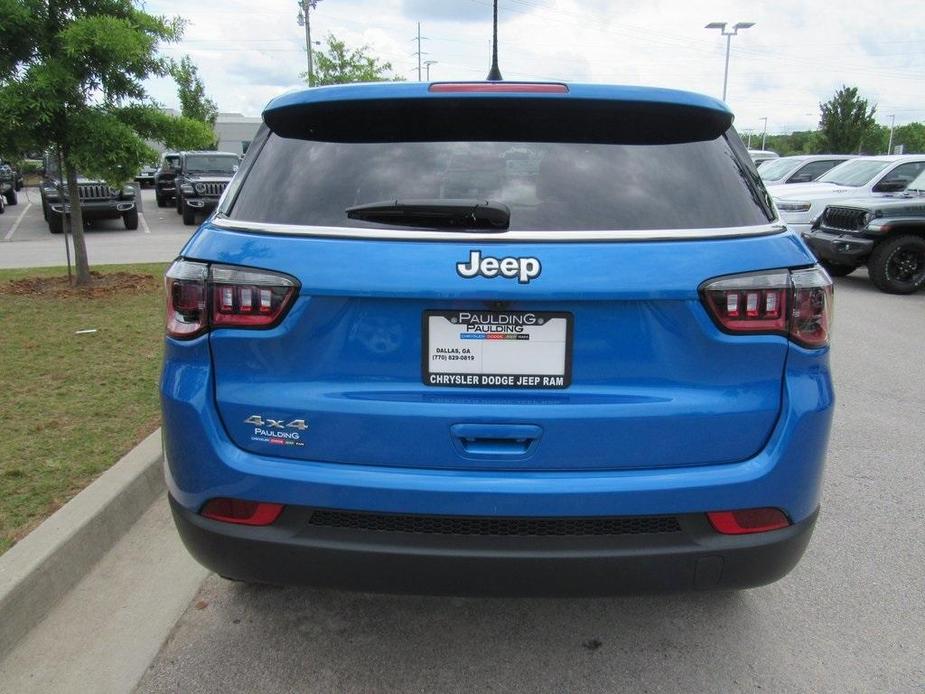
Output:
top-left (700, 267), bottom-right (833, 347)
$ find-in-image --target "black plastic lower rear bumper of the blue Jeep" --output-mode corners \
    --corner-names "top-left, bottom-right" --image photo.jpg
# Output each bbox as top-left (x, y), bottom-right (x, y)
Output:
top-left (170, 496), bottom-right (817, 596)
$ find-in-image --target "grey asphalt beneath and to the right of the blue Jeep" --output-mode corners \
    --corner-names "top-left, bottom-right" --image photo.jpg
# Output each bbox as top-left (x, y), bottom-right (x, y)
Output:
top-left (138, 274), bottom-right (925, 693)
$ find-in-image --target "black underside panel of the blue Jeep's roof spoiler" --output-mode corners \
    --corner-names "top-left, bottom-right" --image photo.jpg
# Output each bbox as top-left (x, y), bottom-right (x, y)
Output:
top-left (263, 94), bottom-right (732, 144)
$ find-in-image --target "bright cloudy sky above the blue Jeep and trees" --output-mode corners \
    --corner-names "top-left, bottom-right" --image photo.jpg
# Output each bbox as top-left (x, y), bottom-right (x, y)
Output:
top-left (145, 0), bottom-right (925, 137)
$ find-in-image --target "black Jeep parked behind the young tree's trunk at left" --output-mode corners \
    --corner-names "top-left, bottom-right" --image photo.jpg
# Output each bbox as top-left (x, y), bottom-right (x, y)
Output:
top-left (40, 157), bottom-right (138, 234)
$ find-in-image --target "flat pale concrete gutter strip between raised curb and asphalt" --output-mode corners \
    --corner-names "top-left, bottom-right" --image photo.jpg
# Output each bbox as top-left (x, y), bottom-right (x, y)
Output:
top-left (0, 496), bottom-right (208, 694)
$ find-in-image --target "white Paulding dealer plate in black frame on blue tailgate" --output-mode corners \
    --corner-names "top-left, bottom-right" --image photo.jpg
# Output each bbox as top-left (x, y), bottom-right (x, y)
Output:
top-left (422, 309), bottom-right (572, 388)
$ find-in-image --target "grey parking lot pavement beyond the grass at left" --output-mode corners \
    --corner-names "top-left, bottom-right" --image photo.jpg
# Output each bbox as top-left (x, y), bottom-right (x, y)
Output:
top-left (0, 188), bottom-right (195, 268)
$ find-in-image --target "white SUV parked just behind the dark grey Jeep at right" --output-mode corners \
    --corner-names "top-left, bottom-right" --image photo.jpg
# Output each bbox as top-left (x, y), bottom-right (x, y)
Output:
top-left (768, 154), bottom-right (925, 234)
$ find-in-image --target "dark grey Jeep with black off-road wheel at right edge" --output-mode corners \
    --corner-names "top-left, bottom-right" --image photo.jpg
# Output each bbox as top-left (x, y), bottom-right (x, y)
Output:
top-left (803, 173), bottom-right (925, 294)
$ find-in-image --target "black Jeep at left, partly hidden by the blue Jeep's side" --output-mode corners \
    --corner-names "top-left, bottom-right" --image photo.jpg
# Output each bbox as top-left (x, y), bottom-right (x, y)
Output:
top-left (176, 152), bottom-right (241, 226)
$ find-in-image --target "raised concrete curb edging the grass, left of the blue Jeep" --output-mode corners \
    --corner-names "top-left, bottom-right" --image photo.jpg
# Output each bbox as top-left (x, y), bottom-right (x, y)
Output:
top-left (0, 429), bottom-right (164, 658)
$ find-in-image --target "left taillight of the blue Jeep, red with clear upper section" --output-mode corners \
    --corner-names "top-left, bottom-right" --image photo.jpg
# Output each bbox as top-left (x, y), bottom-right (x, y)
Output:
top-left (165, 260), bottom-right (298, 339)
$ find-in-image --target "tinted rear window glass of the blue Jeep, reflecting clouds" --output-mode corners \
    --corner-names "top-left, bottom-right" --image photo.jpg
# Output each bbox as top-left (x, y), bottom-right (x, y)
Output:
top-left (229, 132), bottom-right (773, 231)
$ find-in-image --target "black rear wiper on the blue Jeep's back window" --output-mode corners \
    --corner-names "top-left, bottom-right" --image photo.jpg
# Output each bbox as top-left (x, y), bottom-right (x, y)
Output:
top-left (345, 198), bottom-right (511, 231)
